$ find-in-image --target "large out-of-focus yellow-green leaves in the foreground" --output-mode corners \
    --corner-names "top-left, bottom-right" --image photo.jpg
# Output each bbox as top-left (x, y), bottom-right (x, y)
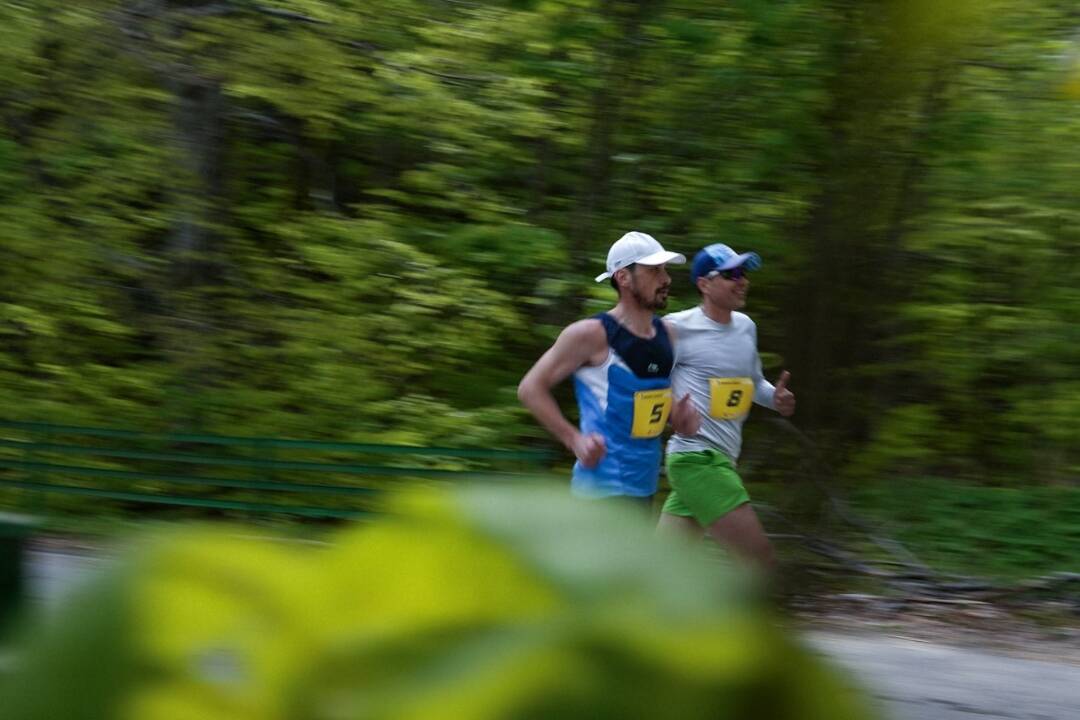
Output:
top-left (0, 487), bottom-right (868, 720)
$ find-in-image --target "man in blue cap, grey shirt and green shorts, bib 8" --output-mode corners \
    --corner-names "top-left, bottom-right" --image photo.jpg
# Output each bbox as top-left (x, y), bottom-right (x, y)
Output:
top-left (659, 244), bottom-right (795, 569)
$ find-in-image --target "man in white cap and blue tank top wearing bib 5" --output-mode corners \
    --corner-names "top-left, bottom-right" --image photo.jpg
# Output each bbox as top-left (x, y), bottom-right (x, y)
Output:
top-left (517, 232), bottom-right (700, 501)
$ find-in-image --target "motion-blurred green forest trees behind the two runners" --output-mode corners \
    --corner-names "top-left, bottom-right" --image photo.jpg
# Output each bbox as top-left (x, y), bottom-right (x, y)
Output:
top-left (0, 0), bottom-right (1080, 574)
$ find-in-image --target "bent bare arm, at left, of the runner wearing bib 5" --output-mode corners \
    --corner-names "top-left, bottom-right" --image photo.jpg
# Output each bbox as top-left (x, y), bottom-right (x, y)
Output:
top-left (517, 320), bottom-right (607, 467)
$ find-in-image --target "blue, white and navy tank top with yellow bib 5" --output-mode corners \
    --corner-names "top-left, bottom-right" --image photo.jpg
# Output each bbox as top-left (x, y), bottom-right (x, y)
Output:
top-left (570, 313), bottom-right (674, 498)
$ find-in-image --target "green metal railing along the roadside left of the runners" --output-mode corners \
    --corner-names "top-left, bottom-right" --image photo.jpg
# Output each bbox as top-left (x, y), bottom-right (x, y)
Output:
top-left (0, 420), bottom-right (552, 518)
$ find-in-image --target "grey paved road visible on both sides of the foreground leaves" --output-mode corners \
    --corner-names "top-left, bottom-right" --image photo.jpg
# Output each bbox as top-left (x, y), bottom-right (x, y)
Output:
top-left (14, 551), bottom-right (1080, 720)
